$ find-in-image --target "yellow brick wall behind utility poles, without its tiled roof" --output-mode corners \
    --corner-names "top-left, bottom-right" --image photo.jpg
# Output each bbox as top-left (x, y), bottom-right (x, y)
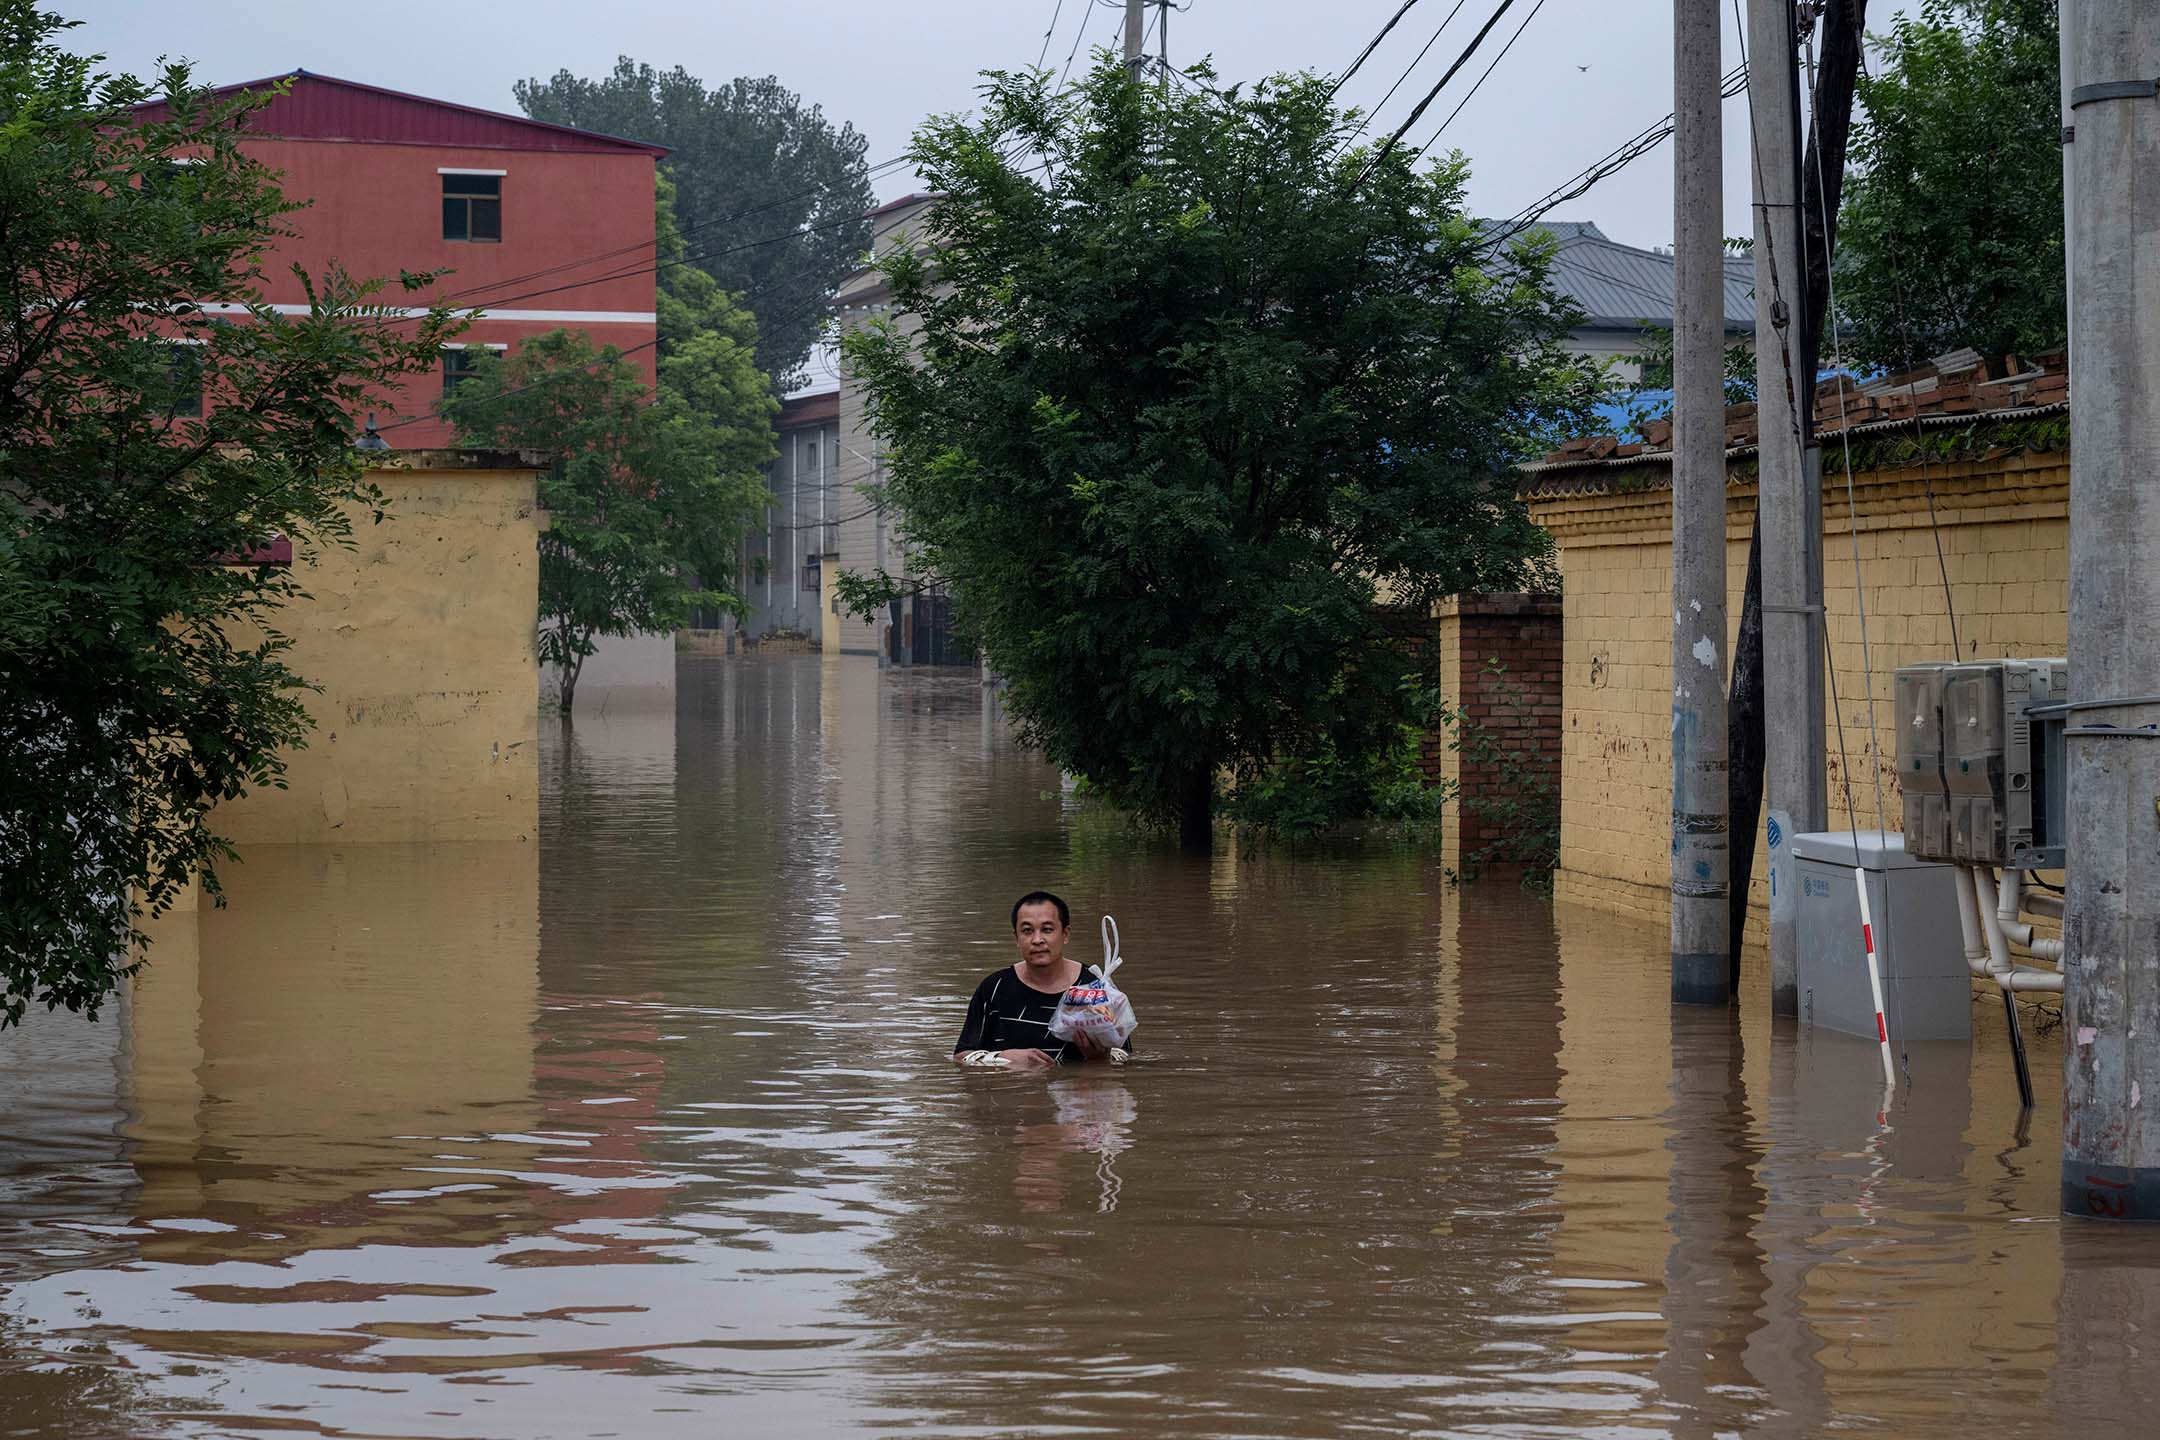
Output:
top-left (1531, 447), bottom-right (2069, 920)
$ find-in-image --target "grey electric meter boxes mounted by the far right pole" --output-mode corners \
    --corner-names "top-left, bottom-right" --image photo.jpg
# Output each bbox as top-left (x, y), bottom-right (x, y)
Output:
top-left (1894, 658), bottom-right (2069, 870)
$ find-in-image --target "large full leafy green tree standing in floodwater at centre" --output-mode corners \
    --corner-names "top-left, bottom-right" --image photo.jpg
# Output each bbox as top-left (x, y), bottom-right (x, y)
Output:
top-left (845, 60), bottom-right (1596, 848)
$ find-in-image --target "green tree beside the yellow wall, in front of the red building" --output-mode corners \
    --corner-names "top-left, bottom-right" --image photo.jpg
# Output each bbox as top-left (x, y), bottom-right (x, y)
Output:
top-left (443, 300), bottom-right (780, 717)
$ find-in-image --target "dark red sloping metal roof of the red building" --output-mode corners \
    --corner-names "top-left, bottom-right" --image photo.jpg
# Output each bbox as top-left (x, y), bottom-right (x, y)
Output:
top-left (136, 69), bottom-right (667, 158)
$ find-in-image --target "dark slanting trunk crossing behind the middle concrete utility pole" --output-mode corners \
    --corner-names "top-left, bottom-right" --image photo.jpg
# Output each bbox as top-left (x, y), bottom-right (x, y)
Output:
top-left (1726, 0), bottom-right (1868, 967)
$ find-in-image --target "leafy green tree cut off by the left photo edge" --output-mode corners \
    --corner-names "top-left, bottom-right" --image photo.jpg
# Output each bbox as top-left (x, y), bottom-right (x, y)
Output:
top-left (0, 0), bottom-right (454, 1028)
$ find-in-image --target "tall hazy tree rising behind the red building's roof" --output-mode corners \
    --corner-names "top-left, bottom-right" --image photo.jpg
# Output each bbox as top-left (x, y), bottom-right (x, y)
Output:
top-left (516, 56), bottom-right (877, 391)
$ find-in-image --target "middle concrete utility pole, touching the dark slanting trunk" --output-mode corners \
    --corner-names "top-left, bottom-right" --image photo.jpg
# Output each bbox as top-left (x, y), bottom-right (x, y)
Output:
top-left (1747, 0), bottom-right (1827, 1015)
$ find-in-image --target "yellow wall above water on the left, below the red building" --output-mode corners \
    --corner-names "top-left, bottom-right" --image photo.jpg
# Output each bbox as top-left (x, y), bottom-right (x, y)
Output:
top-left (214, 451), bottom-right (540, 844)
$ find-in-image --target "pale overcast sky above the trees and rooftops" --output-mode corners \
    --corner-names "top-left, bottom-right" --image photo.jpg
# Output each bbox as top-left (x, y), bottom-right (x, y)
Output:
top-left (54, 0), bottom-right (1894, 246)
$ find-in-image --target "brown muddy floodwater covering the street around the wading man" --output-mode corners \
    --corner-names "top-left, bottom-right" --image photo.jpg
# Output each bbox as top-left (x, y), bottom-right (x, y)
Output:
top-left (0, 658), bottom-right (2160, 1440)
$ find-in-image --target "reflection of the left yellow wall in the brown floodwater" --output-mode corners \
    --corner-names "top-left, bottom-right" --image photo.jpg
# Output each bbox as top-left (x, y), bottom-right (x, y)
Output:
top-left (127, 842), bottom-right (540, 1263)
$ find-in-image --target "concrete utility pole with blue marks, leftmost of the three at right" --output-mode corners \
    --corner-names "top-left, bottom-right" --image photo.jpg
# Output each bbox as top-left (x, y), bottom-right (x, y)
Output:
top-left (1672, 0), bottom-right (1732, 1004)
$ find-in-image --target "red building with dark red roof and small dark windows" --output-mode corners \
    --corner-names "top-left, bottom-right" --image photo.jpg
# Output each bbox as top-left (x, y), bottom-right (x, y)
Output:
top-left (143, 71), bottom-right (667, 449)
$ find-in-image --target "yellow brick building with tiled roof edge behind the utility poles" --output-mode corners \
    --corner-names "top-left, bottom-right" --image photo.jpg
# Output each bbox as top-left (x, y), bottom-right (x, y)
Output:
top-left (1523, 358), bottom-right (2069, 920)
